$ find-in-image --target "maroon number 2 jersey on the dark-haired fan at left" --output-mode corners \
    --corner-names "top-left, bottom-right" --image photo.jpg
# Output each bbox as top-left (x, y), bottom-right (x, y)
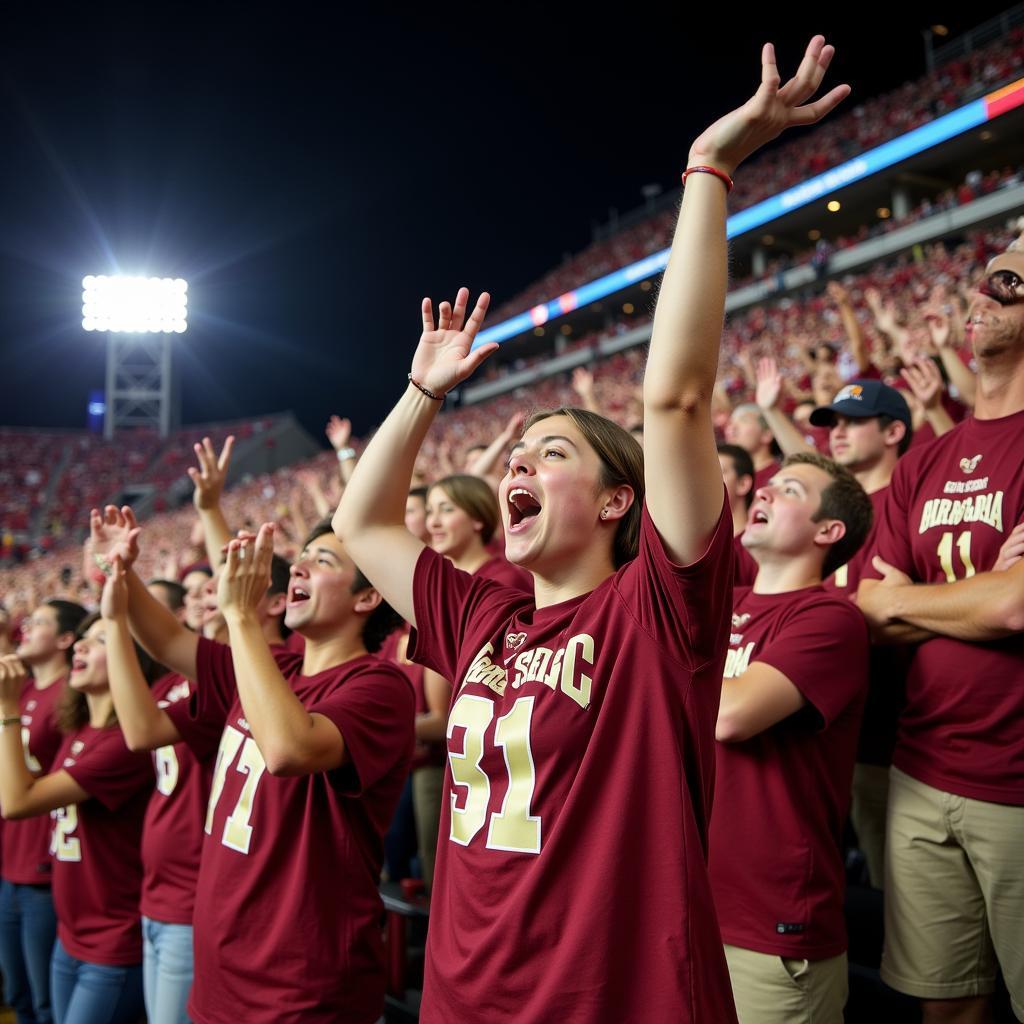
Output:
top-left (50, 725), bottom-right (153, 967)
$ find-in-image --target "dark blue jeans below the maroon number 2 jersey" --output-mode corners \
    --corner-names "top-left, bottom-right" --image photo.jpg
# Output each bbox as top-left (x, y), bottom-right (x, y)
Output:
top-left (50, 939), bottom-right (143, 1024)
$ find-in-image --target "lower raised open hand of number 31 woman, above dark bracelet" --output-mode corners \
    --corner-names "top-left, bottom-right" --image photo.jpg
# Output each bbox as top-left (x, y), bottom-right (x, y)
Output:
top-left (412, 288), bottom-right (498, 397)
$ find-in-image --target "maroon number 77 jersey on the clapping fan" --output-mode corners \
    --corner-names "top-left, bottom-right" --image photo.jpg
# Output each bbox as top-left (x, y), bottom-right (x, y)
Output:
top-left (167, 639), bottom-right (414, 1024)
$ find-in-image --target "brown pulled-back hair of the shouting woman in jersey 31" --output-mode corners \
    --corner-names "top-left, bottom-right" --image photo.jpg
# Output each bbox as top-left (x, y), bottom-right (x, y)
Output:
top-left (525, 406), bottom-right (644, 569)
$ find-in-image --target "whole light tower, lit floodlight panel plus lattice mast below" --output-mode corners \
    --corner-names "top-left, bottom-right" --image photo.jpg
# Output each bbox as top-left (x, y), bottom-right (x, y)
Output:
top-left (82, 275), bottom-right (188, 439)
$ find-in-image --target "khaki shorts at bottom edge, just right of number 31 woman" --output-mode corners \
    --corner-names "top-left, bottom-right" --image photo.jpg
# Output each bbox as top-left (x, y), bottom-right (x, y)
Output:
top-left (725, 945), bottom-right (849, 1024)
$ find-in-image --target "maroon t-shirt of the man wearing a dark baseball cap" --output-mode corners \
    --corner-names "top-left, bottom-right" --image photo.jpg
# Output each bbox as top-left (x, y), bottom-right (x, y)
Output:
top-left (824, 487), bottom-right (913, 768)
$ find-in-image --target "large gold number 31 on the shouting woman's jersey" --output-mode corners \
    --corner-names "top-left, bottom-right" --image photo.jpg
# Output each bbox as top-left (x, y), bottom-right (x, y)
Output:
top-left (447, 693), bottom-right (541, 853)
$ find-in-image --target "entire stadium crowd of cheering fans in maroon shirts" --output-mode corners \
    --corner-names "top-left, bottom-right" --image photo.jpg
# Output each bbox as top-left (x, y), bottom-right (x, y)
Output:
top-left (0, 28), bottom-right (1024, 1024)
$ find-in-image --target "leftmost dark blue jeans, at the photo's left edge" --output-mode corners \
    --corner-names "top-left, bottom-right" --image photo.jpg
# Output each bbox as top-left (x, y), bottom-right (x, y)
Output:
top-left (0, 882), bottom-right (57, 1024)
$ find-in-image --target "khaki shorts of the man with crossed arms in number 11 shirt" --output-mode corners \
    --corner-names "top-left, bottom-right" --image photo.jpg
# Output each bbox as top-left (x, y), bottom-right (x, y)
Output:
top-left (882, 768), bottom-right (1024, 1020)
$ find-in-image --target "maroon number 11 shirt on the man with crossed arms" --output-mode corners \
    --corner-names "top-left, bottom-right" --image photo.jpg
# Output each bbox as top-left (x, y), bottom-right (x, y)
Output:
top-left (865, 413), bottom-right (1024, 805)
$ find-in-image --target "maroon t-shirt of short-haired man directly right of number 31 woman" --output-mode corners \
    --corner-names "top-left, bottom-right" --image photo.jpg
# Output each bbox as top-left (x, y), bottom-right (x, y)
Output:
top-left (710, 587), bottom-right (868, 959)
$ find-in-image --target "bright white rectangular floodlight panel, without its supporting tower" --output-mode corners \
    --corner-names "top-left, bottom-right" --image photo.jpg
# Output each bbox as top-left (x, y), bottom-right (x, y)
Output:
top-left (82, 274), bottom-right (188, 334)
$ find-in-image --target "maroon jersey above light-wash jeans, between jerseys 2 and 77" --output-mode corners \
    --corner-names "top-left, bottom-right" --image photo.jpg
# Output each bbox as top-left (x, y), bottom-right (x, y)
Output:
top-left (140, 673), bottom-right (213, 925)
